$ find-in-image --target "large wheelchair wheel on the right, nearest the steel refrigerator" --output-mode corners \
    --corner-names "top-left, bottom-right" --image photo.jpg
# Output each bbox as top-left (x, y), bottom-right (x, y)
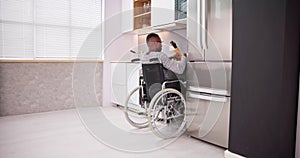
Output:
top-left (148, 88), bottom-right (186, 138)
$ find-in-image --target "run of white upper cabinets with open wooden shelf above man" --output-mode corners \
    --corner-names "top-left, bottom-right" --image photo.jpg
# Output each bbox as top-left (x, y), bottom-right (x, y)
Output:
top-left (122, 0), bottom-right (187, 33)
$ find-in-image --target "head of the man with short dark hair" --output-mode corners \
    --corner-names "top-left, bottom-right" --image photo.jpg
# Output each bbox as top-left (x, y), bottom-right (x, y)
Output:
top-left (146, 33), bottom-right (162, 52)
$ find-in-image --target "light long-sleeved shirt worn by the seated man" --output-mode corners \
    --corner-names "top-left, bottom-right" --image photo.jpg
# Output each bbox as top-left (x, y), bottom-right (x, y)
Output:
top-left (141, 52), bottom-right (186, 74)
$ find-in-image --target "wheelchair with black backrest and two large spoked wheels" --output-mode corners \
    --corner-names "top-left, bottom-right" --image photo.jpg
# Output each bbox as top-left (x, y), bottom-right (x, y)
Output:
top-left (124, 63), bottom-right (186, 139)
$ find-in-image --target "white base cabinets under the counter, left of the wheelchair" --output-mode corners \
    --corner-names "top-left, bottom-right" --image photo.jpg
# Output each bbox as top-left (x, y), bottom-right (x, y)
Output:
top-left (111, 62), bottom-right (141, 106)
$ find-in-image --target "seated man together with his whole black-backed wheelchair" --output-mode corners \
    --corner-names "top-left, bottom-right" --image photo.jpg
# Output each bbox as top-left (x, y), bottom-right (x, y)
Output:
top-left (124, 33), bottom-right (186, 138)
